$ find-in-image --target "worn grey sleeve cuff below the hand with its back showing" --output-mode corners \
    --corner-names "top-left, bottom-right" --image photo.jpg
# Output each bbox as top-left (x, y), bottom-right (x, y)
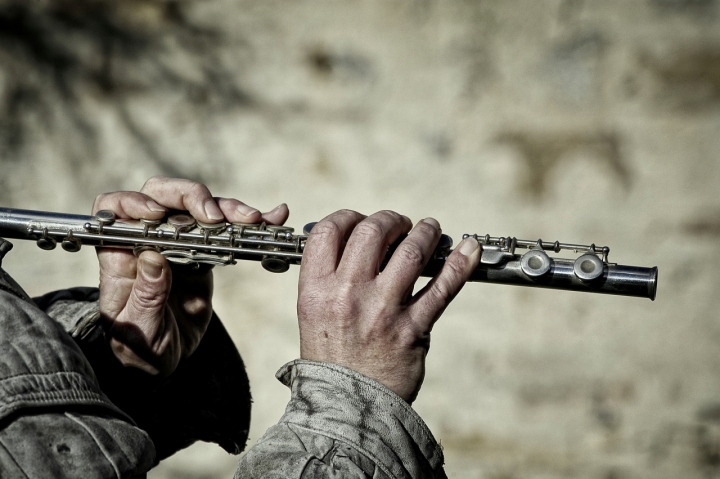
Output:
top-left (235, 360), bottom-right (446, 479)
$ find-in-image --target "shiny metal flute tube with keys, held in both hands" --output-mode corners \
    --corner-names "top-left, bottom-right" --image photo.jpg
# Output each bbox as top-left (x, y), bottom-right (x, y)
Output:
top-left (0, 208), bottom-right (658, 300)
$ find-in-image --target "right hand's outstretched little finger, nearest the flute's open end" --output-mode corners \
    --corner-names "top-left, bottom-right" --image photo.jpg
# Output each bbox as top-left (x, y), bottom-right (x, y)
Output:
top-left (408, 237), bottom-right (480, 329)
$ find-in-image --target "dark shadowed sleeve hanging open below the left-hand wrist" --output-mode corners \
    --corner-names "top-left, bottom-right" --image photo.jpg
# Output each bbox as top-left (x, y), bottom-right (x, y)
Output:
top-left (34, 288), bottom-right (252, 460)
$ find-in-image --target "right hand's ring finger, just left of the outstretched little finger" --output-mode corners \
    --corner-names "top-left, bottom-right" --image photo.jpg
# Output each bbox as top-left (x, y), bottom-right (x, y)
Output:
top-left (379, 218), bottom-right (440, 304)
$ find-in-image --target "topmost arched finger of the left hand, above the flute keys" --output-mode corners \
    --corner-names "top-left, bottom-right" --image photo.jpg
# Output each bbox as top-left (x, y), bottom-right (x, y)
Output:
top-left (140, 176), bottom-right (225, 223)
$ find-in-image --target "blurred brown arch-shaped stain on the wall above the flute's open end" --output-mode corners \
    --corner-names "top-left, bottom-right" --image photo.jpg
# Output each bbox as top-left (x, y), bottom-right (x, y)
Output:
top-left (495, 131), bottom-right (631, 199)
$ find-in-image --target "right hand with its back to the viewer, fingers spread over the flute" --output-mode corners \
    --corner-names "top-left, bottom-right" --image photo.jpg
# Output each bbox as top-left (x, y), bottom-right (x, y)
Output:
top-left (298, 211), bottom-right (480, 403)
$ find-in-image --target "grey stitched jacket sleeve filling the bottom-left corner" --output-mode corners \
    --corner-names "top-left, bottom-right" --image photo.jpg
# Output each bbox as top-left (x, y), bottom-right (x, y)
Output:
top-left (0, 269), bottom-right (156, 478)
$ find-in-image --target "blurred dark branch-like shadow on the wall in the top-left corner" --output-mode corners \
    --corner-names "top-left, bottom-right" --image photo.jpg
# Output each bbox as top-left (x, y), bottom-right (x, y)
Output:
top-left (0, 0), bottom-right (251, 195)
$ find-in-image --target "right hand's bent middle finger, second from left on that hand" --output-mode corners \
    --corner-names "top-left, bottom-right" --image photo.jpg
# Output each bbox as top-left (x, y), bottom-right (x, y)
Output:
top-left (337, 211), bottom-right (412, 282)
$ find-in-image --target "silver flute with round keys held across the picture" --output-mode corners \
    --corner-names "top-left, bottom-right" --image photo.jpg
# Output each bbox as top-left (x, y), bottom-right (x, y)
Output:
top-left (0, 208), bottom-right (658, 300)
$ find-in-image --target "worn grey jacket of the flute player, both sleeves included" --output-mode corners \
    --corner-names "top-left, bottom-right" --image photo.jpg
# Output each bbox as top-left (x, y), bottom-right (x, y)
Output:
top-left (0, 239), bottom-right (445, 479)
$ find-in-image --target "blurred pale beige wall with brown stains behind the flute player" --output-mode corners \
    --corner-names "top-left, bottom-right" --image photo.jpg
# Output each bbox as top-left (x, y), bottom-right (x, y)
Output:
top-left (0, 0), bottom-right (720, 479)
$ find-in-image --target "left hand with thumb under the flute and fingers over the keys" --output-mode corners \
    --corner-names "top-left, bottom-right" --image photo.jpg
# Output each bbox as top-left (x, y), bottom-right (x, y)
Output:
top-left (92, 176), bottom-right (289, 376)
